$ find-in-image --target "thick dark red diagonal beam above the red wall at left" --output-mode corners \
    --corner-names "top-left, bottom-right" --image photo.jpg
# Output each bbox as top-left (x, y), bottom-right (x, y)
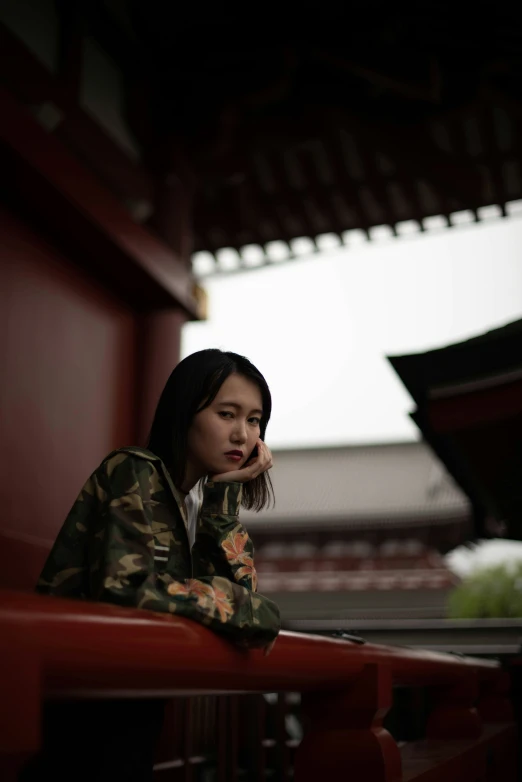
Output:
top-left (0, 88), bottom-right (198, 318)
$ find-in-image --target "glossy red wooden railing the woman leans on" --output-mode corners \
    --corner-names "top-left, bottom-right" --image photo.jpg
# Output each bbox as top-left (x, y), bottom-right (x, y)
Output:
top-left (0, 592), bottom-right (516, 782)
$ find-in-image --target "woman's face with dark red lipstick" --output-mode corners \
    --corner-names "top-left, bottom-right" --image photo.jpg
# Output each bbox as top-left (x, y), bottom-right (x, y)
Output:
top-left (187, 374), bottom-right (263, 482)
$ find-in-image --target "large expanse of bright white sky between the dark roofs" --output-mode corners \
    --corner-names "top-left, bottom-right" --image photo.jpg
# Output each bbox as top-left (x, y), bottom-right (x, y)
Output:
top-left (182, 216), bottom-right (522, 448)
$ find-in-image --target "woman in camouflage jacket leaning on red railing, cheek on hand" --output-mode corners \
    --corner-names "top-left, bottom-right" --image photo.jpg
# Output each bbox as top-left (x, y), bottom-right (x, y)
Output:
top-left (27, 350), bottom-right (280, 780)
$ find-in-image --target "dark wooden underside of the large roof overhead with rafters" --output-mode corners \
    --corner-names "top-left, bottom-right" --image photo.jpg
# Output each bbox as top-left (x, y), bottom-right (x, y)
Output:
top-left (87, 0), bottom-right (522, 260)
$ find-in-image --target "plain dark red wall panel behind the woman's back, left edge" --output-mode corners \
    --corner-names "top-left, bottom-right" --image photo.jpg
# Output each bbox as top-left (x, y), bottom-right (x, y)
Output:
top-left (0, 207), bottom-right (137, 588)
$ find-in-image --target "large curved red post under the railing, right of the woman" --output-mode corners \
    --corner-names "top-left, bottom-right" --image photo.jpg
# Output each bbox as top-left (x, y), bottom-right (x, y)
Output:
top-left (295, 664), bottom-right (401, 782)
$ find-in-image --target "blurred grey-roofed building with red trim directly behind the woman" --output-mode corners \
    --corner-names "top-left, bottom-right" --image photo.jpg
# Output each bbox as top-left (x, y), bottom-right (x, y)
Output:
top-left (243, 443), bottom-right (472, 626)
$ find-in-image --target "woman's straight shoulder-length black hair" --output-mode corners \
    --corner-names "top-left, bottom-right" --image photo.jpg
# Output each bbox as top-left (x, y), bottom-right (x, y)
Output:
top-left (147, 348), bottom-right (273, 510)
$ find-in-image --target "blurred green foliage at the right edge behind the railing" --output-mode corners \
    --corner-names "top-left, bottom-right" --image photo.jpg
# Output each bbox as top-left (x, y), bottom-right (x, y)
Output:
top-left (448, 563), bottom-right (522, 619)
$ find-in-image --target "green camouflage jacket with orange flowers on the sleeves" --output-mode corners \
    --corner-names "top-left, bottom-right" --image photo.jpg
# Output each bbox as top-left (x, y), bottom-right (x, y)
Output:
top-left (36, 448), bottom-right (280, 646)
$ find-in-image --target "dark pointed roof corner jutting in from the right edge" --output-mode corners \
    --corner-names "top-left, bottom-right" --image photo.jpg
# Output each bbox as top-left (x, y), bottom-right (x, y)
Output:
top-left (390, 318), bottom-right (522, 540)
